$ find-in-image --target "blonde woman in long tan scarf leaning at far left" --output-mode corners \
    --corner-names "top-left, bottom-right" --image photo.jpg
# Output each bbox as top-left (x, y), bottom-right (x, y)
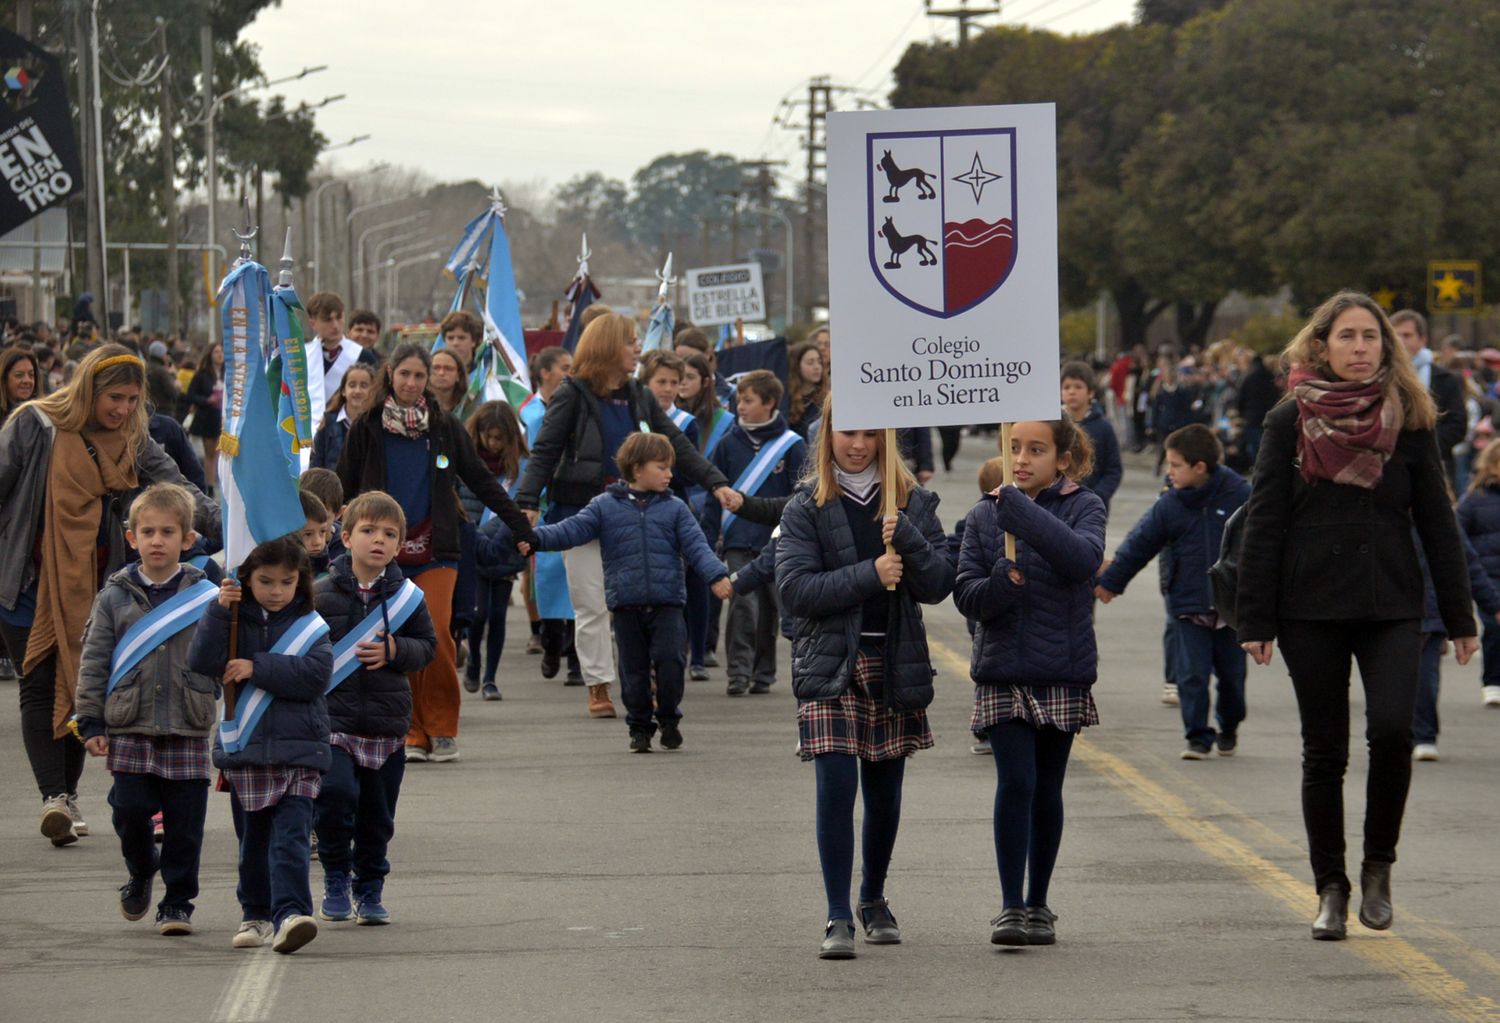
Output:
top-left (0, 345), bottom-right (219, 846)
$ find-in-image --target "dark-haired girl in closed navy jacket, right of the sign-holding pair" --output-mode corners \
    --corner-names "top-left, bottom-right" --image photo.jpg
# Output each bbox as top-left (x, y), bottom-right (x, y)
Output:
top-left (954, 417), bottom-right (1106, 945)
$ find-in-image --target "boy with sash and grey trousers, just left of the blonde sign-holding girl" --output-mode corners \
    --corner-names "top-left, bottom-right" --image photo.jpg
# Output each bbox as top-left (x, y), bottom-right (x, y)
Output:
top-left (704, 369), bottom-right (807, 696)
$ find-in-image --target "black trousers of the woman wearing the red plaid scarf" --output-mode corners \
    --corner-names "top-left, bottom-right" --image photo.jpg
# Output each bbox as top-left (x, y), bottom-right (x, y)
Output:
top-left (1278, 620), bottom-right (1422, 891)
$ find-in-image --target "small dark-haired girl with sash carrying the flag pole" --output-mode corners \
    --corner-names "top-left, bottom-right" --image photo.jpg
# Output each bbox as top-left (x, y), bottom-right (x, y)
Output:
top-left (188, 534), bottom-right (333, 953)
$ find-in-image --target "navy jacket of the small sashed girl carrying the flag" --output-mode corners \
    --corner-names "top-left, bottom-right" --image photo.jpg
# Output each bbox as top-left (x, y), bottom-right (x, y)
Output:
top-left (188, 588), bottom-right (333, 771)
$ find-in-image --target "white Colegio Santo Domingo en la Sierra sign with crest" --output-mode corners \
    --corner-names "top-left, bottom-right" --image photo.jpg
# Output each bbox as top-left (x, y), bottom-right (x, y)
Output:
top-left (828, 104), bottom-right (1059, 431)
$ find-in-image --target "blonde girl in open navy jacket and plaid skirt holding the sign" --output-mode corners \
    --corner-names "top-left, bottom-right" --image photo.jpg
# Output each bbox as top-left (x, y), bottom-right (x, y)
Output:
top-left (776, 399), bottom-right (954, 959)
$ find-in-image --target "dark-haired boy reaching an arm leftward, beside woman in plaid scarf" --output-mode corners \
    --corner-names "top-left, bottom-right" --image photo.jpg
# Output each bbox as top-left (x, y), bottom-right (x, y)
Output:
top-left (1095, 423), bottom-right (1250, 761)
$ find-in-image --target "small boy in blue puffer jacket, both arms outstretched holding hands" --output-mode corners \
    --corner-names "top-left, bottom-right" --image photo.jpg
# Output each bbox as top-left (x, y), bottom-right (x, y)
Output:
top-left (522, 434), bottom-right (731, 753)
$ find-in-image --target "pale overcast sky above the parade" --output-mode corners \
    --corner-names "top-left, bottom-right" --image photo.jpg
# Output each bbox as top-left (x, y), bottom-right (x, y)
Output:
top-left (248, 0), bottom-right (1136, 193)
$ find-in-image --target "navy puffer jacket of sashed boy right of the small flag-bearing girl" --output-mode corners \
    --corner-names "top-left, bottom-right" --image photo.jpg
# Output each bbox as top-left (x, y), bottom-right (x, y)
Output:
top-left (314, 555), bottom-right (438, 737)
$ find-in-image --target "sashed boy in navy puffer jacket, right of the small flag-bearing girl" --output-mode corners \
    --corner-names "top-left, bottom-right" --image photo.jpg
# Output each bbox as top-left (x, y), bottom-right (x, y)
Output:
top-left (314, 491), bottom-right (438, 924)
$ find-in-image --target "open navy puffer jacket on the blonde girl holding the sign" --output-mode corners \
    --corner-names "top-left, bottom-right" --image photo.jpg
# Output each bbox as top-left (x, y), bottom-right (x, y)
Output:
top-left (776, 485), bottom-right (953, 711)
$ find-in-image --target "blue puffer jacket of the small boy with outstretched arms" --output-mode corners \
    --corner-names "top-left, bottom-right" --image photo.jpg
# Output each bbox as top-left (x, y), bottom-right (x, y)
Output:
top-left (537, 483), bottom-right (729, 611)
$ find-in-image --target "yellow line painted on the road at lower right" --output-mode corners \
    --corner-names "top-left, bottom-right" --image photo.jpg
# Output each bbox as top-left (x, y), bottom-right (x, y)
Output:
top-left (930, 641), bottom-right (1500, 1023)
